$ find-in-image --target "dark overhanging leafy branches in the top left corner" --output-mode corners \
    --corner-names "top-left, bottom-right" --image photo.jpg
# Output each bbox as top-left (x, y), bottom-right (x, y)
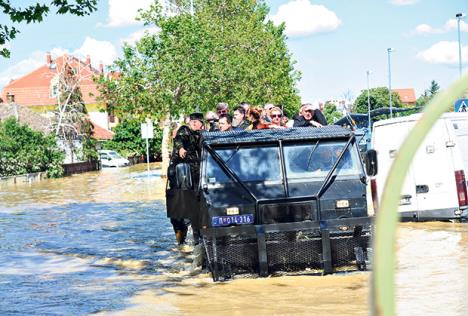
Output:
top-left (0, 0), bottom-right (98, 58)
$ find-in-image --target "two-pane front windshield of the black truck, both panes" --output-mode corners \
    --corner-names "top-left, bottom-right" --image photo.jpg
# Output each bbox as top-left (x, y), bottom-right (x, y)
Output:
top-left (205, 141), bottom-right (362, 184)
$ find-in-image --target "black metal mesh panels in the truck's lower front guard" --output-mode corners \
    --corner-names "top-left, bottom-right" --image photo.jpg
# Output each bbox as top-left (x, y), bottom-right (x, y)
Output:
top-left (203, 229), bottom-right (370, 280)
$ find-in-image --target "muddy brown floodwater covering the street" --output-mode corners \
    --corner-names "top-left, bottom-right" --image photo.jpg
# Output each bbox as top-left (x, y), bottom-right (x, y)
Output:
top-left (0, 165), bottom-right (468, 315)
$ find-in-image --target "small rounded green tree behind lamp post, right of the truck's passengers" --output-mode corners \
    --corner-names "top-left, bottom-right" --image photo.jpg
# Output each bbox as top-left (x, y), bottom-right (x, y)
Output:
top-left (353, 87), bottom-right (403, 113)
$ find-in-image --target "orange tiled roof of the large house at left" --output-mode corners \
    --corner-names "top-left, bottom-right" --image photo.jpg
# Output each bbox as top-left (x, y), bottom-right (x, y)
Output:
top-left (0, 55), bottom-right (100, 106)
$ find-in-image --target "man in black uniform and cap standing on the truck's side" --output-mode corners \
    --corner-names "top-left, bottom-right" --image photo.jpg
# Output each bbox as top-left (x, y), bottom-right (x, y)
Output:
top-left (166, 113), bottom-right (204, 244)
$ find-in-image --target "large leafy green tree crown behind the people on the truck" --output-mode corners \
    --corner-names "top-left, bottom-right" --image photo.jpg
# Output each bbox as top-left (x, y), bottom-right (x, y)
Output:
top-left (100, 0), bottom-right (300, 119)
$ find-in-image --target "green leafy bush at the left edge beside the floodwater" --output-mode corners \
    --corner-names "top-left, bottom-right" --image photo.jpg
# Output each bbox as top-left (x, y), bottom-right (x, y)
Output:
top-left (0, 118), bottom-right (63, 177)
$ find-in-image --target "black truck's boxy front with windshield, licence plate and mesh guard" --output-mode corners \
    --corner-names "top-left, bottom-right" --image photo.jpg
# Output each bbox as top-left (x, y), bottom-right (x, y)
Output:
top-left (170, 126), bottom-right (371, 280)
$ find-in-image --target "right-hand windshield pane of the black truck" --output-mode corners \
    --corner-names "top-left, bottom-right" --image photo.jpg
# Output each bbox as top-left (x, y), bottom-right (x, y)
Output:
top-left (284, 142), bottom-right (362, 180)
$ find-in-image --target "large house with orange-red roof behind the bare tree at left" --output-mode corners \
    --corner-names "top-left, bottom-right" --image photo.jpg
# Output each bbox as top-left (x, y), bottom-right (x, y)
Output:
top-left (0, 53), bottom-right (113, 140)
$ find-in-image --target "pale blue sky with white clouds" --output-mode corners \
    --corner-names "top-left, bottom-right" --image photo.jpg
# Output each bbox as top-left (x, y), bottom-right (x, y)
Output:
top-left (0, 0), bottom-right (468, 102)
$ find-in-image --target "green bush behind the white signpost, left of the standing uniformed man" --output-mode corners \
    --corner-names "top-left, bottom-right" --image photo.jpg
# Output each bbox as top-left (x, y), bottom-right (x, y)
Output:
top-left (104, 120), bottom-right (162, 162)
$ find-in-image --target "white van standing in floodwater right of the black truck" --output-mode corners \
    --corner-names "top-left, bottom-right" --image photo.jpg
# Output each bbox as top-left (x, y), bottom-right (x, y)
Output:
top-left (371, 113), bottom-right (468, 221)
